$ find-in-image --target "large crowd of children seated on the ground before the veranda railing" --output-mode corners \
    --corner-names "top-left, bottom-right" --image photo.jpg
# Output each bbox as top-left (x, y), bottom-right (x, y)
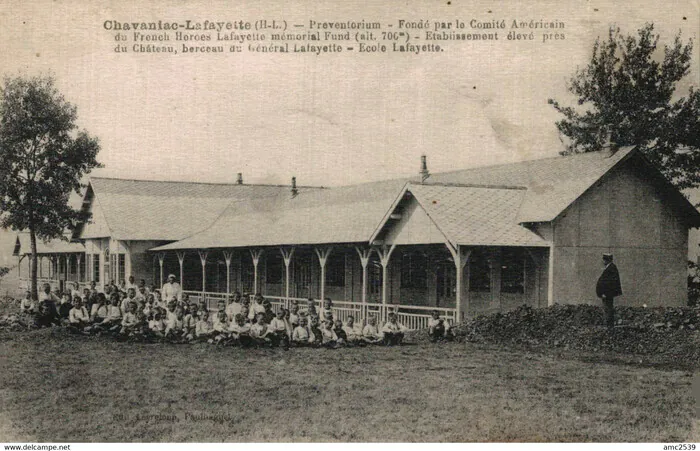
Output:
top-left (20, 284), bottom-right (451, 348)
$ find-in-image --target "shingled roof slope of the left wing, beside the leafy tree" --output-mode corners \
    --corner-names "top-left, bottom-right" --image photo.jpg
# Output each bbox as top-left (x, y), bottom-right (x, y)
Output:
top-left (77, 177), bottom-right (318, 241)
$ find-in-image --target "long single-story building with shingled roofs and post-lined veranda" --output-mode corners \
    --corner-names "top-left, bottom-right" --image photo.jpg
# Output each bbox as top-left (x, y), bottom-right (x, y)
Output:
top-left (15, 148), bottom-right (700, 327)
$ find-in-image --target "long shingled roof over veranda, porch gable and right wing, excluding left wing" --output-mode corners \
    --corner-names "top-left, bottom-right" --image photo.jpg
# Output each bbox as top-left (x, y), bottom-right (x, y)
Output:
top-left (154, 148), bottom-right (648, 251)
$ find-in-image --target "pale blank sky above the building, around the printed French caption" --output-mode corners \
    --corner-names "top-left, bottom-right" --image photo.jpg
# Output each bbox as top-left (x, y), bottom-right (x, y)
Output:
top-left (0, 0), bottom-right (700, 264)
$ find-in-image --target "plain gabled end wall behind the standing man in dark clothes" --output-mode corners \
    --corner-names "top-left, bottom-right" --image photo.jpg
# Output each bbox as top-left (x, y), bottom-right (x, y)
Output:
top-left (553, 164), bottom-right (688, 306)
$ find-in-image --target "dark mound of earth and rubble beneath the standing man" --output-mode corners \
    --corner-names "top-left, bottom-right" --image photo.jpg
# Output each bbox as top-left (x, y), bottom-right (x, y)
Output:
top-left (411, 305), bottom-right (700, 367)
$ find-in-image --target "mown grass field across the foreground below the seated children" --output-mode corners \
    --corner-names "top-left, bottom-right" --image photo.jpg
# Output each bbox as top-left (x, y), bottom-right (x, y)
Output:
top-left (0, 330), bottom-right (695, 442)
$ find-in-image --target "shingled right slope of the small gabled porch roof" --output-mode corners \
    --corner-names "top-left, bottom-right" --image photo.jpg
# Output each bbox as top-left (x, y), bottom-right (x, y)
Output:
top-left (382, 183), bottom-right (549, 247)
